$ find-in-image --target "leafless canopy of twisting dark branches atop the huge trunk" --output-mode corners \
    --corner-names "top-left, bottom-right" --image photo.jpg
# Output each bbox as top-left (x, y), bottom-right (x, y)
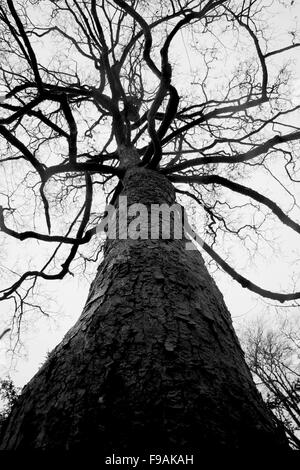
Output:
top-left (0, 0), bottom-right (300, 338)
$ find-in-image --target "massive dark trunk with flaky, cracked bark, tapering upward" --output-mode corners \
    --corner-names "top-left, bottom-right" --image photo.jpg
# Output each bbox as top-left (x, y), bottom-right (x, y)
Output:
top-left (1, 163), bottom-right (286, 454)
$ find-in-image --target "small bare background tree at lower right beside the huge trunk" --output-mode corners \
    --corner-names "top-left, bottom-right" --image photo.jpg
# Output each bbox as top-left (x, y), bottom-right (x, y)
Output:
top-left (242, 319), bottom-right (300, 450)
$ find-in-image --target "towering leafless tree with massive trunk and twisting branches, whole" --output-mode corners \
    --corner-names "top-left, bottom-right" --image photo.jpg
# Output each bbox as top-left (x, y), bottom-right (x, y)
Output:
top-left (0, 0), bottom-right (300, 452)
